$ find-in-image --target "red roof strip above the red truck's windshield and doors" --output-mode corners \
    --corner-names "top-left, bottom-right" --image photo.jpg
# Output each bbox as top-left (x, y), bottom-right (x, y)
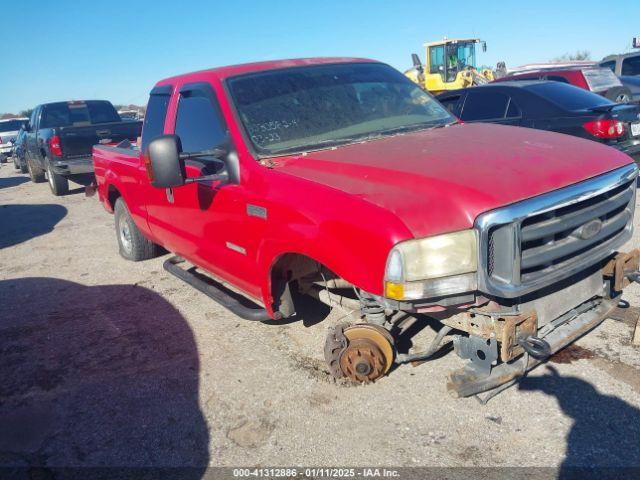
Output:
top-left (156, 57), bottom-right (379, 86)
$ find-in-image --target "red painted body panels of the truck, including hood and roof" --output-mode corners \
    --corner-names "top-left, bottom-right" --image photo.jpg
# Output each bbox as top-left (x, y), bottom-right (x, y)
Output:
top-left (93, 59), bottom-right (631, 318)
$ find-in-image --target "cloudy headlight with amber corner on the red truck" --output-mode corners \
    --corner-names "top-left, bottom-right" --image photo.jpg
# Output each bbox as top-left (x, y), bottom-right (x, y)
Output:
top-left (385, 230), bottom-right (478, 300)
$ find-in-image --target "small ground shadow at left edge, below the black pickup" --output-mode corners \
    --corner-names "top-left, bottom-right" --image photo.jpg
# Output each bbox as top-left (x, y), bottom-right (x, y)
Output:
top-left (0, 203), bottom-right (67, 248)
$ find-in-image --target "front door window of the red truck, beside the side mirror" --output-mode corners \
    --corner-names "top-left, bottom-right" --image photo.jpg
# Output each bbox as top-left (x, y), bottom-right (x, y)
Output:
top-left (175, 90), bottom-right (227, 152)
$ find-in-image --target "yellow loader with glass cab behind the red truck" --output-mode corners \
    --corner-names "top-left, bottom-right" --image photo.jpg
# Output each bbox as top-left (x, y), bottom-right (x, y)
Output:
top-left (405, 38), bottom-right (494, 95)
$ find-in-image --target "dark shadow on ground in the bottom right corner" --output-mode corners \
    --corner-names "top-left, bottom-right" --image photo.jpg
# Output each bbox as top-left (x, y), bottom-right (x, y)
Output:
top-left (519, 366), bottom-right (640, 480)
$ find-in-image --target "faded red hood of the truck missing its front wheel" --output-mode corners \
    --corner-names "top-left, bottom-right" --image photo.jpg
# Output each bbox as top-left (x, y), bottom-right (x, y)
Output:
top-left (274, 124), bottom-right (632, 237)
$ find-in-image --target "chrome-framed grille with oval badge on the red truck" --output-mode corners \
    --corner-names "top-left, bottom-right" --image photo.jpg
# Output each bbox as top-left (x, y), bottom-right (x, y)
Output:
top-left (476, 165), bottom-right (637, 298)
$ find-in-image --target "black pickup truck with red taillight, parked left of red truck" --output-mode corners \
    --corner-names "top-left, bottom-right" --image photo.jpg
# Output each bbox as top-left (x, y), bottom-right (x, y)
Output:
top-left (24, 100), bottom-right (142, 195)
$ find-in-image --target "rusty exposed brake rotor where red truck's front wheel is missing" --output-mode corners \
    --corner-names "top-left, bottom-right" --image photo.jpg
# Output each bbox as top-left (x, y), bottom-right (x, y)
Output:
top-left (325, 324), bottom-right (394, 382)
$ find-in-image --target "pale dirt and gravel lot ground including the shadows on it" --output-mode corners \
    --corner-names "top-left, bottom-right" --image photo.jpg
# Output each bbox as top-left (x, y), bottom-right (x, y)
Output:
top-left (0, 164), bottom-right (640, 476)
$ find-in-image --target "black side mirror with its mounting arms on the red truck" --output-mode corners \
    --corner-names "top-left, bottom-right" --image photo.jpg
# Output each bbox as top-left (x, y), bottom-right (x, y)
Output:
top-left (144, 135), bottom-right (235, 188)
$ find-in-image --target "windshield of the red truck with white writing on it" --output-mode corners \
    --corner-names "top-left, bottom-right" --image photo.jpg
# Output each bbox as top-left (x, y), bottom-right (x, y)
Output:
top-left (228, 63), bottom-right (456, 155)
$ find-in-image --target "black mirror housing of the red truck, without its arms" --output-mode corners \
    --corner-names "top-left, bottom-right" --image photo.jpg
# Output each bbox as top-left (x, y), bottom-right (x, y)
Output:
top-left (145, 135), bottom-right (187, 188)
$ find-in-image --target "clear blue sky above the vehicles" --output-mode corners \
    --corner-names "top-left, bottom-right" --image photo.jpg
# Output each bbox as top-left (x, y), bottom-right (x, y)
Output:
top-left (0, 0), bottom-right (640, 112)
